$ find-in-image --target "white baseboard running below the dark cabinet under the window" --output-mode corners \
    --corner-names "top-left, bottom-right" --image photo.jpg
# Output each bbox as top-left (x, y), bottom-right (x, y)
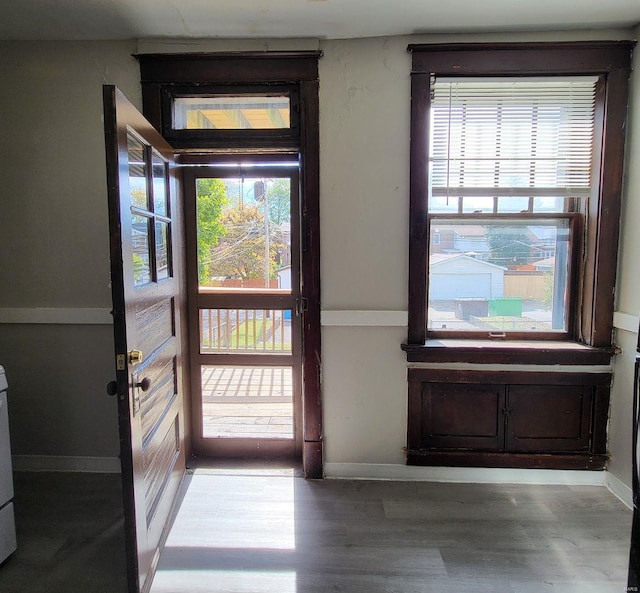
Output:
top-left (324, 463), bottom-right (606, 486)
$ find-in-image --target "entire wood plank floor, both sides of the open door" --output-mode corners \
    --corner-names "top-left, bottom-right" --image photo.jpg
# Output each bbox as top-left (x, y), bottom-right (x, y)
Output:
top-left (0, 466), bottom-right (631, 593)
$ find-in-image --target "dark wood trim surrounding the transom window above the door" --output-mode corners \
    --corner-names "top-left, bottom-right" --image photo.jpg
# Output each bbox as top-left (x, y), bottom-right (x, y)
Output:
top-left (136, 51), bottom-right (322, 152)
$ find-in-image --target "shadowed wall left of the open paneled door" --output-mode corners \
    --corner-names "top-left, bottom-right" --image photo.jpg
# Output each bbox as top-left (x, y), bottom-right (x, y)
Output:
top-left (0, 42), bottom-right (141, 468)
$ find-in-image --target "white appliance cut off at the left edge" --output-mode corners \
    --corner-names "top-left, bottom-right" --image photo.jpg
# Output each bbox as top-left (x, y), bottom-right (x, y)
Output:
top-left (0, 366), bottom-right (16, 564)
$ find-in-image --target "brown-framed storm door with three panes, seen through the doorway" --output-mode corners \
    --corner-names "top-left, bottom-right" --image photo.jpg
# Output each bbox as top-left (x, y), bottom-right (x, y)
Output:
top-left (183, 157), bottom-right (302, 460)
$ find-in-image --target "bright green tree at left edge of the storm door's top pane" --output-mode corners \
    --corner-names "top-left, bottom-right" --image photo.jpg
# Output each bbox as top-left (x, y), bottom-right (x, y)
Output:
top-left (196, 178), bottom-right (228, 286)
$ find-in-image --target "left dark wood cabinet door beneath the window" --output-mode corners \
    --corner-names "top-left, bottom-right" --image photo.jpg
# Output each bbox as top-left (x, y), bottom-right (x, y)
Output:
top-left (420, 383), bottom-right (505, 451)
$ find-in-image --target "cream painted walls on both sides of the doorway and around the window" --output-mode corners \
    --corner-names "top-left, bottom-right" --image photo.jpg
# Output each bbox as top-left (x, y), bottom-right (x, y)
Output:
top-left (0, 31), bottom-right (640, 483)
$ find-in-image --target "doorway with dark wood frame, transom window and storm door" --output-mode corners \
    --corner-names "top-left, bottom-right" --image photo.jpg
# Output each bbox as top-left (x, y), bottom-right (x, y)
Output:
top-left (136, 51), bottom-right (323, 478)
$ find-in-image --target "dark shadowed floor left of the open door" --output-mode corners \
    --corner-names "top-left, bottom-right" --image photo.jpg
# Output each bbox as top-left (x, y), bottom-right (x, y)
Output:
top-left (0, 472), bottom-right (127, 593)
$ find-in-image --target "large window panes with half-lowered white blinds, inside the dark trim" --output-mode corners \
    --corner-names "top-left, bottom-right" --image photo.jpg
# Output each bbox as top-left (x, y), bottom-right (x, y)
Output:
top-left (427, 77), bottom-right (598, 336)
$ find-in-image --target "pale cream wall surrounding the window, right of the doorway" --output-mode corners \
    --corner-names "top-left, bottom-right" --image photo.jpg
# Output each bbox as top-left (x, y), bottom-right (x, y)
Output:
top-left (320, 31), bottom-right (640, 474)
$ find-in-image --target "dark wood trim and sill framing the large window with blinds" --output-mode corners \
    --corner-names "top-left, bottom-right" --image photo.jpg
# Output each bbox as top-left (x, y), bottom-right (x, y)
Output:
top-left (403, 41), bottom-right (634, 364)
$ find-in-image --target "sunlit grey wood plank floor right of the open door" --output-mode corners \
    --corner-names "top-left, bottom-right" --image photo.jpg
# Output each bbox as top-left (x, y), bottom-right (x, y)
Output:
top-left (152, 470), bottom-right (631, 593)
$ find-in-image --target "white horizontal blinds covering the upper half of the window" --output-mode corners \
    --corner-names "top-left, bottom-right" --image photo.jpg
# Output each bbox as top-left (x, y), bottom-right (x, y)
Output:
top-left (430, 77), bottom-right (597, 197)
